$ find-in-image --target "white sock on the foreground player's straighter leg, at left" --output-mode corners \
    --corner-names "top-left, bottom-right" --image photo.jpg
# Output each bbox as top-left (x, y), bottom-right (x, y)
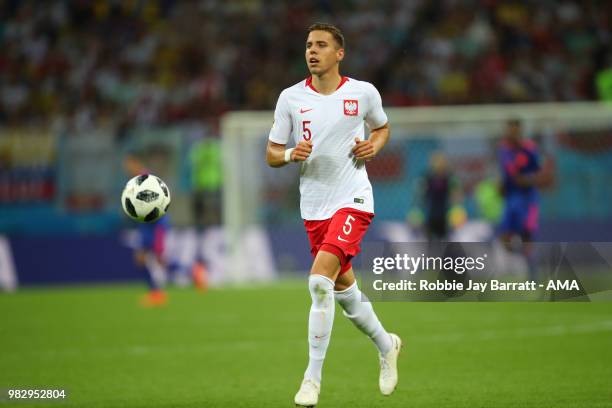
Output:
top-left (304, 275), bottom-right (335, 383)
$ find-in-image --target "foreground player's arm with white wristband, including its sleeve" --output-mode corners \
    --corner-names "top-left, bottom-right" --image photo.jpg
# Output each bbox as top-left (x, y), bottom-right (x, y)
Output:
top-left (266, 90), bottom-right (312, 167)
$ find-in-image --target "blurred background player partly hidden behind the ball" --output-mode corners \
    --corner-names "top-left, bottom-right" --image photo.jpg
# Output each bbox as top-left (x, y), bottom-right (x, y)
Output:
top-left (123, 153), bottom-right (169, 306)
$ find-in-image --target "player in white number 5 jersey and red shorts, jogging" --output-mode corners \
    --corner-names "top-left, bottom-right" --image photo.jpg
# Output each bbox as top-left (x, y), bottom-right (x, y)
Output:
top-left (266, 23), bottom-right (401, 407)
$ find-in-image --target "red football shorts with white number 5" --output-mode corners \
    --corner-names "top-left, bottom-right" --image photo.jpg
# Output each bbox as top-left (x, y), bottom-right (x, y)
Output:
top-left (304, 208), bottom-right (374, 275)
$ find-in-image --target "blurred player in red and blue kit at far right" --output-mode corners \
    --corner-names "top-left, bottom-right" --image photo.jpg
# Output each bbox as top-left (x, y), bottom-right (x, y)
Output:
top-left (499, 119), bottom-right (541, 280)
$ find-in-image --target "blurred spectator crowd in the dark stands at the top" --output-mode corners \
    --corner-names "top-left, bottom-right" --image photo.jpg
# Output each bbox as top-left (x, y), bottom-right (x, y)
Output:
top-left (0, 0), bottom-right (612, 133)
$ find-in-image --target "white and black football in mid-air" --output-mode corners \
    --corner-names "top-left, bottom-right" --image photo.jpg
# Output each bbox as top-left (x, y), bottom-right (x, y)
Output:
top-left (121, 174), bottom-right (170, 222)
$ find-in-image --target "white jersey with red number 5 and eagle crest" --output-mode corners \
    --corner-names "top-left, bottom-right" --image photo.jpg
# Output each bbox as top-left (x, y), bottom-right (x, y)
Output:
top-left (269, 77), bottom-right (387, 220)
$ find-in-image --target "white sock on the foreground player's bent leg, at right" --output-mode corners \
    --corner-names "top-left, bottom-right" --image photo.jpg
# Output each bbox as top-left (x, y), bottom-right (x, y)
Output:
top-left (334, 282), bottom-right (393, 354)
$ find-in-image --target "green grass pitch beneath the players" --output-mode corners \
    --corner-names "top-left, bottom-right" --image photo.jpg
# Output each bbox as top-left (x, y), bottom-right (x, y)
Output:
top-left (0, 282), bottom-right (612, 408)
